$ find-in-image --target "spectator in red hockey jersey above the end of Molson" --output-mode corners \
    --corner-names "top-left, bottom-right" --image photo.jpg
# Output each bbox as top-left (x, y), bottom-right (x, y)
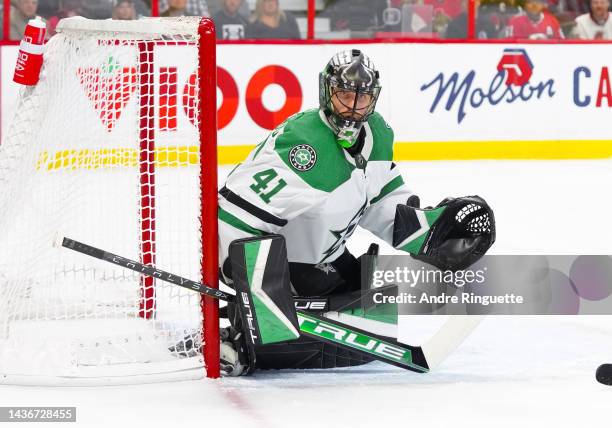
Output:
top-left (505, 0), bottom-right (565, 39)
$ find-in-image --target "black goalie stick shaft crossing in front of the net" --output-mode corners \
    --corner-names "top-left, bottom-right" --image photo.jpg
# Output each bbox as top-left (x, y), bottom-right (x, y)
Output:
top-left (62, 238), bottom-right (234, 302)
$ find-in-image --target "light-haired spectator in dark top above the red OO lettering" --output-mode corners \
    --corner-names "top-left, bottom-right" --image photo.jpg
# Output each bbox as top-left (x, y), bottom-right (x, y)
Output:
top-left (247, 0), bottom-right (300, 39)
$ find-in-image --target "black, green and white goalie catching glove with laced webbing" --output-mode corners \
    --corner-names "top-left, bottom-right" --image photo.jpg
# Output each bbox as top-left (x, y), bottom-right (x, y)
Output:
top-left (393, 196), bottom-right (495, 270)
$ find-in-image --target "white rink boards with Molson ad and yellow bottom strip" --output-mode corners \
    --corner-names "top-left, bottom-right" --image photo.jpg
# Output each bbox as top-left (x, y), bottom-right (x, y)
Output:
top-left (0, 43), bottom-right (612, 163)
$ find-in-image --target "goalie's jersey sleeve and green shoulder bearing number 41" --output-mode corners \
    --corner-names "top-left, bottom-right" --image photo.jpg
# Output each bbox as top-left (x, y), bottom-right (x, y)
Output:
top-left (219, 108), bottom-right (334, 261)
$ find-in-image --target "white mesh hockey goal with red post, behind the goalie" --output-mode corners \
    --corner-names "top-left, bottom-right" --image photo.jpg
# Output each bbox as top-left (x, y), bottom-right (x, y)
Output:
top-left (0, 17), bottom-right (219, 385)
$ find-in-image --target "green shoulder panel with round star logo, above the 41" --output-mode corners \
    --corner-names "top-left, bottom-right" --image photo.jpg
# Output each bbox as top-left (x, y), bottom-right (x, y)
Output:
top-left (273, 109), bottom-right (354, 192)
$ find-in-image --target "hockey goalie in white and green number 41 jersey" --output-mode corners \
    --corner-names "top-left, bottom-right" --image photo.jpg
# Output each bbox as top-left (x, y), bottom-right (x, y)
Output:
top-left (214, 49), bottom-right (495, 376)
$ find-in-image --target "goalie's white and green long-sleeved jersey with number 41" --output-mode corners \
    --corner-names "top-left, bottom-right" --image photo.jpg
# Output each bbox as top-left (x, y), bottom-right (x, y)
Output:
top-left (219, 109), bottom-right (412, 264)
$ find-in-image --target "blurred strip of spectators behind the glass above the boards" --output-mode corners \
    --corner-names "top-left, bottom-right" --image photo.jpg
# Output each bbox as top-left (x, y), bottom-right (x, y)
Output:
top-left (0, 0), bottom-right (612, 40)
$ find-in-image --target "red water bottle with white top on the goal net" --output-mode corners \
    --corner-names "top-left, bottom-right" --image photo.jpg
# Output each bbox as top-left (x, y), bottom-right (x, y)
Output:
top-left (13, 16), bottom-right (47, 86)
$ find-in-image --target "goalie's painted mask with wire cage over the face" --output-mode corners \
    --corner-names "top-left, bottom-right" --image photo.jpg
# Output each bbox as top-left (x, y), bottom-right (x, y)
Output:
top-left (319, 49), bottom-right (380, 148)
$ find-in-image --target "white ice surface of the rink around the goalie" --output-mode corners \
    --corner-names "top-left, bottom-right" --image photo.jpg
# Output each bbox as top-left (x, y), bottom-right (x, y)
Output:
top-left (0, 160), bottom-right (612, 428)
